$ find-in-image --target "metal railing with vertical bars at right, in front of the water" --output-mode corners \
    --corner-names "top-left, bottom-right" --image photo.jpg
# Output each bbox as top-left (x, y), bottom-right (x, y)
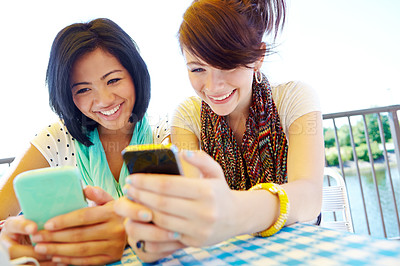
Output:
top-left (323, 105), bottom-right (400, 237)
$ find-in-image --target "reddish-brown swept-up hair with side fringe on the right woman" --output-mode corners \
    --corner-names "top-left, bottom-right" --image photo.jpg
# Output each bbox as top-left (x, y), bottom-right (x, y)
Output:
top-left (178, 0), bottom-right (286, 69)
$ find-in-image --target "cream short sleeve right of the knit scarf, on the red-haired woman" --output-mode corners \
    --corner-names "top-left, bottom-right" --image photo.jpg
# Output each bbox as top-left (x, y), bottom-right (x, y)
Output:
top-left (272, 82), bottom-right (321, 135)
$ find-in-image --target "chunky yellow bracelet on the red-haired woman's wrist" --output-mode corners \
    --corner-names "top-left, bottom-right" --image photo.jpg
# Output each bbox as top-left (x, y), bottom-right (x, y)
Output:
top-left (250, 183), bottom-right (290, 237)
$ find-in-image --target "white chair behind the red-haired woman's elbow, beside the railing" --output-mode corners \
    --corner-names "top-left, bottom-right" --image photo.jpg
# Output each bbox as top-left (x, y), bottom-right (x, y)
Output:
top-left (320, 167), bottom-right (354, 233)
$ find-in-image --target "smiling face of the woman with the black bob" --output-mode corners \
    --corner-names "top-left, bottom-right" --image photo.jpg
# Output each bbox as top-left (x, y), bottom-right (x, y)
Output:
top-left (71, 48), bottom-right (136, 131)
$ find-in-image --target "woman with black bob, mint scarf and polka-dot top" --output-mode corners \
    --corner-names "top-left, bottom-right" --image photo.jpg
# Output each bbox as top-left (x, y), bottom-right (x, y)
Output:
top-left (0, 19), bottom-right (153, 265)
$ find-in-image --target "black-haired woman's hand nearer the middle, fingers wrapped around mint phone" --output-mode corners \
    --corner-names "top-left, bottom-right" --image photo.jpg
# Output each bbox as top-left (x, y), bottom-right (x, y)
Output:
top-left (32, 186), bottom-right (127, 265)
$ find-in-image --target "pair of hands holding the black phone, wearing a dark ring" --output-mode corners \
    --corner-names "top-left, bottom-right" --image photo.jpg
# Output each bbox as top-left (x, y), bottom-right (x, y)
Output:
top-left (115, 151), bottom-right (238, 262)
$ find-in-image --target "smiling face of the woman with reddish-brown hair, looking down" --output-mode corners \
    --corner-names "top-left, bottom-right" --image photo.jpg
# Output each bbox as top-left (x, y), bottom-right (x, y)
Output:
top-left (183, 50), bottom-right (258, 116)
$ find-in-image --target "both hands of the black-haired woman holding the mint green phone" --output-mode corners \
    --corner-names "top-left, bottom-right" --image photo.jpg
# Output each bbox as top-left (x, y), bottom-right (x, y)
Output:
top-left (0, 186), bottom-right (126, 265)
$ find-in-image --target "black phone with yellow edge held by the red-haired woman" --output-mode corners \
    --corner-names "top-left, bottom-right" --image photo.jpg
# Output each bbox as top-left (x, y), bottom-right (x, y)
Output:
top-left (122, 144), bottom-right (182, 175)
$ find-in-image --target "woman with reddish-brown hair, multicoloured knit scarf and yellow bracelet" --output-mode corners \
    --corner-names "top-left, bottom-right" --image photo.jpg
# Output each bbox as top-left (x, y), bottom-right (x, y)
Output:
top-left (115, 0), bottom-right (324, 261)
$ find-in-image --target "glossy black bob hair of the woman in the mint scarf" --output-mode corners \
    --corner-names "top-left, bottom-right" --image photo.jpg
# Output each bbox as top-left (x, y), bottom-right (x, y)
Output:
top-left (46, 18), bottom-right (150, 146)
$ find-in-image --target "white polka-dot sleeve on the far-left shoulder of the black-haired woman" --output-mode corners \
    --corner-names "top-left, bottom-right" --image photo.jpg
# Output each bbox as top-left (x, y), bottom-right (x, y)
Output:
top-left (31, 121), bottom-right (76, 167)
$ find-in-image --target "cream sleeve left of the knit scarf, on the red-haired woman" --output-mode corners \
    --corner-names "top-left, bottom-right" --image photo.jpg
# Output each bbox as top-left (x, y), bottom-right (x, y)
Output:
top-left (171, 96), bottom-right (201, 139)
